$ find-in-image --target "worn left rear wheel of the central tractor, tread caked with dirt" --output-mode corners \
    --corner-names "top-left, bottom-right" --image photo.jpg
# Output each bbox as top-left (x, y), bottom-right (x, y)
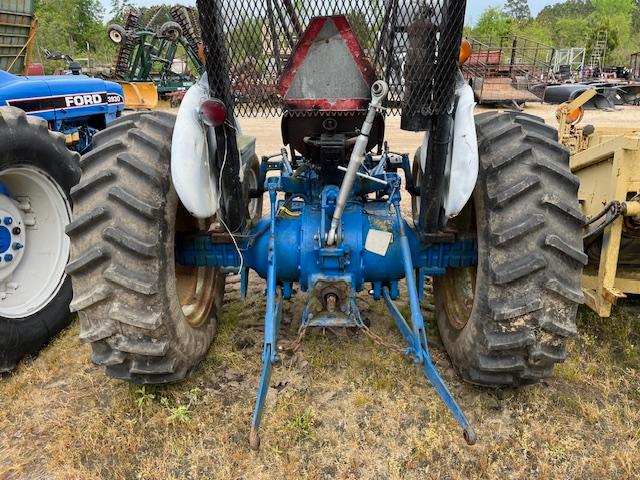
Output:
top-left (67, 112), bottom-right (225, 384)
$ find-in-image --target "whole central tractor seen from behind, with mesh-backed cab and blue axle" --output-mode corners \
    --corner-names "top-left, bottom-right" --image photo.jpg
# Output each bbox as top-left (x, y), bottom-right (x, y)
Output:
top-left (68, 0), bottom-right (586, 448)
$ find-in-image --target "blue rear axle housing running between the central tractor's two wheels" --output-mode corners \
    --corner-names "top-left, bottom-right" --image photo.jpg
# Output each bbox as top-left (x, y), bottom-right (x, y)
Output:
top-left (176, 213), bottom-right (477, 282)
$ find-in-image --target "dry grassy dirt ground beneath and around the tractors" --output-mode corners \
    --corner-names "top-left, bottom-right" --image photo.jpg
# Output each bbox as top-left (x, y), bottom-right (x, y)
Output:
top-left (0, 106), bottom-right (640, 480)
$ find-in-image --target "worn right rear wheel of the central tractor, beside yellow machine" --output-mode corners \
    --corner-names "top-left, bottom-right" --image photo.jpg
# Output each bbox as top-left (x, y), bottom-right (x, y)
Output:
top-left (434, 113), bottom-right (587, 386)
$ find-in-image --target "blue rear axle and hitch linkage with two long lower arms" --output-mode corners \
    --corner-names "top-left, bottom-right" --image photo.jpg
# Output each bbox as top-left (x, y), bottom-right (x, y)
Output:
top-left (176, 149), bottom-right (477, 449)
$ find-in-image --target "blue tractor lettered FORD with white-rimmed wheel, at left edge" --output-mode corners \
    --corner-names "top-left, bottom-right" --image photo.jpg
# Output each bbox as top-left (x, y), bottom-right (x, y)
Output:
top-left (0, 71), bottom-right (124, 372)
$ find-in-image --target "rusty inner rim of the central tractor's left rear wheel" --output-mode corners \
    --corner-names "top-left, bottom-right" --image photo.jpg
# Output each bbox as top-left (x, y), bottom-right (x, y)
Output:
top-left (175, 206), bottom-right (219, 328)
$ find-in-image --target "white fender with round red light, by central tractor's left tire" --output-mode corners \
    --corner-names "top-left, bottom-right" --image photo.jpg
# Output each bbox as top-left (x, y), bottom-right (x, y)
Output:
top-left (171, 74), bottom-right (218, 218)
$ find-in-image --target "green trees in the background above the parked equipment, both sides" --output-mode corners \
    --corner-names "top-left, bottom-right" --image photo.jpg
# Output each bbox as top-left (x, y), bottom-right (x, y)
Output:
top-left (35, 0), bottom-right (640, 71)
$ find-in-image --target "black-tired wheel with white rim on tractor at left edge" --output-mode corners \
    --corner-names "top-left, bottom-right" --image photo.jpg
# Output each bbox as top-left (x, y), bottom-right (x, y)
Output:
top-left (0, 107), bottom-right (80, 372)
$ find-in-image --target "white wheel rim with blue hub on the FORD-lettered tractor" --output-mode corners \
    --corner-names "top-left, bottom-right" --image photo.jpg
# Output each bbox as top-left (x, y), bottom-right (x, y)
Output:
top-left (0, 167), bottom-right (71, 319)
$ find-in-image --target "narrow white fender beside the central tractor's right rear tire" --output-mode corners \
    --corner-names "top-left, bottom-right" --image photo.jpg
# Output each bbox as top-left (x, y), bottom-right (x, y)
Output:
top-left (444, 83), bottom-right (480, 218)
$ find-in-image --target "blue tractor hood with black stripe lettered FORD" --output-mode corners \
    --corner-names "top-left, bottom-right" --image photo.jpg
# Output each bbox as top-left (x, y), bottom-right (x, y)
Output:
top-left (0, 71), bottom-right (124, 121)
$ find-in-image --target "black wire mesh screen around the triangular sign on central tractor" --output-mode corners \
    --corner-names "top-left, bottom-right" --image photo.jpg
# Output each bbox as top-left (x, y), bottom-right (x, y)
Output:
top-left (198, 0), bottom-right (466, 122)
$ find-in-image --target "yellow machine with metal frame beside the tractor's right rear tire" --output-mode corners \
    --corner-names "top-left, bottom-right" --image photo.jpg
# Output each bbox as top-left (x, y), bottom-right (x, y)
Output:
top-left (557, 89), bottom-right (640, 317)
